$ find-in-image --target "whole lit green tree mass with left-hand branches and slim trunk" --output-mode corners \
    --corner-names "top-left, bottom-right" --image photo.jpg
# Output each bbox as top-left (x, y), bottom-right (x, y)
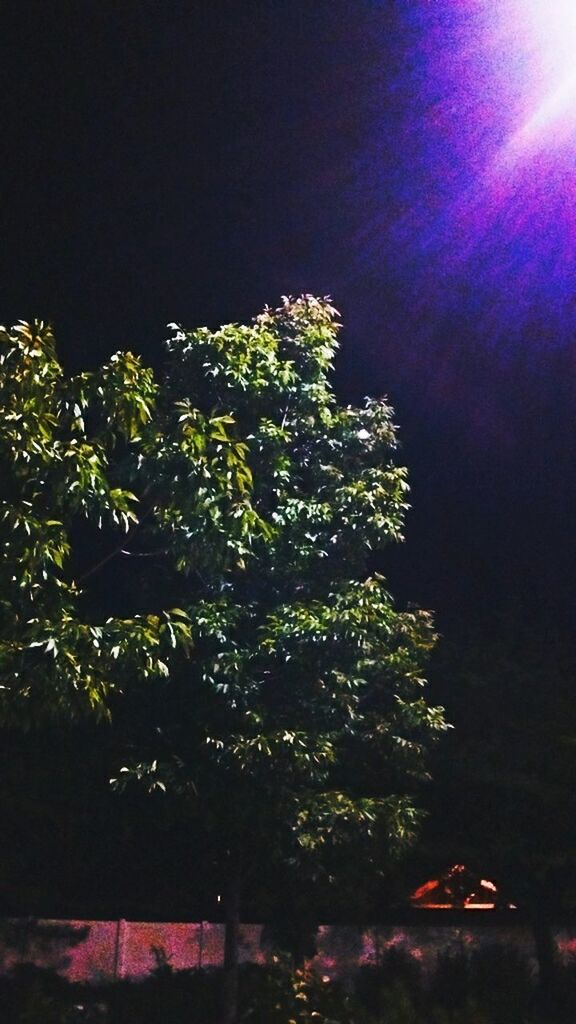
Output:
top-left (0, 296), bottom-right (445, 1024)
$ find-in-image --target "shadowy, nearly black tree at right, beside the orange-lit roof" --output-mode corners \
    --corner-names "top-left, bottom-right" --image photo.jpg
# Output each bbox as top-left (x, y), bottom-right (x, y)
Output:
top-left (416, 620), bottom-right (576, 1001)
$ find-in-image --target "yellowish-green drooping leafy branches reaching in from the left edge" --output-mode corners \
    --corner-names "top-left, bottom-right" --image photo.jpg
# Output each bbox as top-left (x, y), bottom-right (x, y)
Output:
top-left (0, 323), bottom-right (266, 723)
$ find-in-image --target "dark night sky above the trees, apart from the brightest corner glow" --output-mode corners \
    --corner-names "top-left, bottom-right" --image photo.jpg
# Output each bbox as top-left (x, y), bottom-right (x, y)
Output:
top-left (0, 0), bottom-right (576, 636)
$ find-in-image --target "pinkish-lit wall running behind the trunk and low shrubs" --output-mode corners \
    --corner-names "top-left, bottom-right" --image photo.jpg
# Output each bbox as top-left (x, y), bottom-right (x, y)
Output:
top-left (0, 919), bottom-right (576, 983)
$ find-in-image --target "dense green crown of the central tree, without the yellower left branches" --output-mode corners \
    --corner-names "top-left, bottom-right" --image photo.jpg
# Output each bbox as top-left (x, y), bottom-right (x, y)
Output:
top-left (107, 296), bottom-right (445, 905)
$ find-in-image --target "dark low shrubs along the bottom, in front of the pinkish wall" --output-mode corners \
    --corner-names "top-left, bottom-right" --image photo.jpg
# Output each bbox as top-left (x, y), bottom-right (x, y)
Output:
top-left (0, 948), bottom-right (573, 1024)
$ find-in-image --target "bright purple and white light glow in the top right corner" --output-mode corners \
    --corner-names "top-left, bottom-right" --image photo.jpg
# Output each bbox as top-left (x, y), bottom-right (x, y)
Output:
top-left (357, 0), bottom-right (576, 348)
